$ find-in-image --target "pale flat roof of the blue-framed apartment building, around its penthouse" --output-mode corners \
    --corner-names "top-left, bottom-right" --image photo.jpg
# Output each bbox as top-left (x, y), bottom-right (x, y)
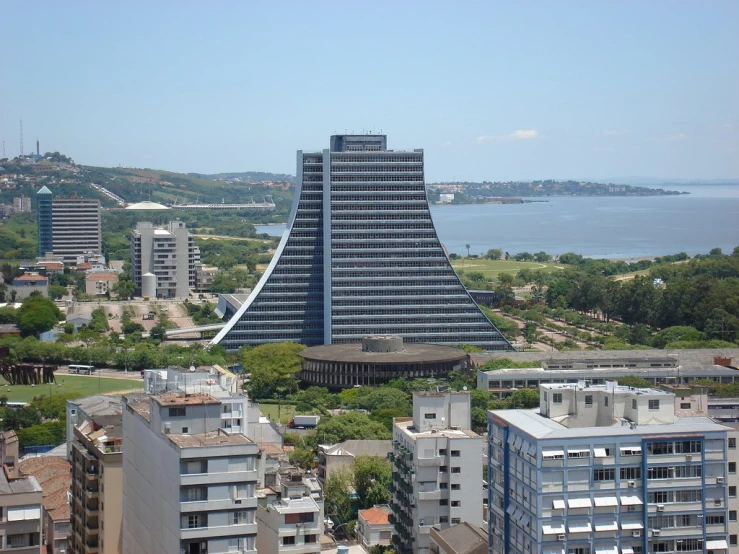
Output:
top-left (488, 408), bottom-right (726, 439)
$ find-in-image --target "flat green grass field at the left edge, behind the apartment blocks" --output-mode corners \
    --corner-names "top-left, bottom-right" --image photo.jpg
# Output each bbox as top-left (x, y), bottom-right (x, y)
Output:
top-left (0, 375), bottom-right (144, 402)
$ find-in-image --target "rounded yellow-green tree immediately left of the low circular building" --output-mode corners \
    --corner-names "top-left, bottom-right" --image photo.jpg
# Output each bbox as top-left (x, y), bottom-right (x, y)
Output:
top-left (242, 342), bottom-right (305, 398)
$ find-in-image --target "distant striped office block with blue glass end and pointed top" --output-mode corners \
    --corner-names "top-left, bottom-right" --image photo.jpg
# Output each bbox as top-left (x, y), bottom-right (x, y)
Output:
top-left (36, 187), bottom-right (102, 264)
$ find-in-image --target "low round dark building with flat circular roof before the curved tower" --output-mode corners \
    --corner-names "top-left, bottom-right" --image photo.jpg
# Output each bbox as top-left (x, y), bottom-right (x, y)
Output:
top-left (300, 335), bottom-right (467, 388)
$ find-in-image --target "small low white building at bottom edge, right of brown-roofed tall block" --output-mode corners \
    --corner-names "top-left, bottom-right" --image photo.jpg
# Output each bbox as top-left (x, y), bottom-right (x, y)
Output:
top-left (257, 496), bottom-right (323, 554)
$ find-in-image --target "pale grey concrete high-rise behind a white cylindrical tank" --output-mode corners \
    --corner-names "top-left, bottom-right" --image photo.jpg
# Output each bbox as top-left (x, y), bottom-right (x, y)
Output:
top-left (131, 221), bottom-right (200, 298)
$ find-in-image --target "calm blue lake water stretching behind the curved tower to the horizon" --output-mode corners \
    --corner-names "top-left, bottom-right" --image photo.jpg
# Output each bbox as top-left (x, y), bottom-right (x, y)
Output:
top-left (257, 185), bottom-right (739, 258)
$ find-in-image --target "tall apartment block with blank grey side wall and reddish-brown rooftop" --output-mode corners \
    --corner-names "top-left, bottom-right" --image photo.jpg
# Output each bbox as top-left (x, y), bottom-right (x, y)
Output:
top-left (123, 391), bottom-right (258, 554)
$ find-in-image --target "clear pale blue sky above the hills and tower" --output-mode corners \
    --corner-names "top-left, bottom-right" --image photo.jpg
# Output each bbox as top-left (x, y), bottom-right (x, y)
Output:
top-left (0, 0), bottom-right (739, 182)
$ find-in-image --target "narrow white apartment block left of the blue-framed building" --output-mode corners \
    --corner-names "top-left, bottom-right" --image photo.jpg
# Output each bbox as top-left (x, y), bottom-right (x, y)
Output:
top-left (391, 392), bottom-right (483, 554)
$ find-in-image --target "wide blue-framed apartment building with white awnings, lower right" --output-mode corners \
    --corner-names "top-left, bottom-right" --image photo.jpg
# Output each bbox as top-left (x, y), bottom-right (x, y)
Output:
top-left (488, 382), bottom-right (736, 554)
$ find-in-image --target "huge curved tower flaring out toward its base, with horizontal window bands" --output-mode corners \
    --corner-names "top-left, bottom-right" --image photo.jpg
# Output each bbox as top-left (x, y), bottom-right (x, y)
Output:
top-left (213, 135), bottom-right (512, 350)
